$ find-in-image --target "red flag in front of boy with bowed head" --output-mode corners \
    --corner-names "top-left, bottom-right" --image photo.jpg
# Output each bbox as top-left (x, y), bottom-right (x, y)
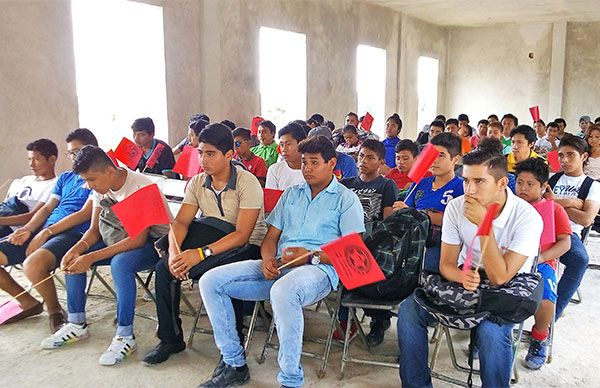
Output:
top-left (111, 183), bottom-right (171, 238)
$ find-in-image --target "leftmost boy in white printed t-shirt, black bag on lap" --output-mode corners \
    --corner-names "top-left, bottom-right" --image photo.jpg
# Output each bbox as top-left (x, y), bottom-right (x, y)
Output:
top-left (0, 139), bottom-right (58, 238)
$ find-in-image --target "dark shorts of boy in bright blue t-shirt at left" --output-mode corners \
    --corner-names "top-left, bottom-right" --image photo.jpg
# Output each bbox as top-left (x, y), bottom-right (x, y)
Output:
top-left (0, 229), bottom-right (83, 267)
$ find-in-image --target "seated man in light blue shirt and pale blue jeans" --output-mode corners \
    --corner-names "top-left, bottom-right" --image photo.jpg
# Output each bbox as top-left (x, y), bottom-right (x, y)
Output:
top-left (200, 136), bottom-right (365, 387)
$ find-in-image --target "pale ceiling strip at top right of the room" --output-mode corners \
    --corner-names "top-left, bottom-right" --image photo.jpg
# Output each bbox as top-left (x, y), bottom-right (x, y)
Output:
top-left (367, 0), bottom-right (600, 26)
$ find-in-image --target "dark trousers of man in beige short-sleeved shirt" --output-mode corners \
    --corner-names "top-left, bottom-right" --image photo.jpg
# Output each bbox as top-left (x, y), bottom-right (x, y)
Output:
top-left (155, 223), bottom-right (260, 344)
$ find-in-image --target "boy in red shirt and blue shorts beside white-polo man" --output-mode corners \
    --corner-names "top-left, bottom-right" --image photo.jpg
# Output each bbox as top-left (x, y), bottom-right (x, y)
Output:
top-left (515, 158), bottom-right (572, 369)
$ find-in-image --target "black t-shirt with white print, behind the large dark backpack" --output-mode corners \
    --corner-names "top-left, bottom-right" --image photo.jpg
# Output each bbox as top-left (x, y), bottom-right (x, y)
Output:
top-left (341, 176), bottom-right (398, 222)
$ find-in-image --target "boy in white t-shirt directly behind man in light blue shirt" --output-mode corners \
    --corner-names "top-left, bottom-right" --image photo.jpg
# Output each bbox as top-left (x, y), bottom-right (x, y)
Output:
top-left (265, 123), bottom-right (306, 190)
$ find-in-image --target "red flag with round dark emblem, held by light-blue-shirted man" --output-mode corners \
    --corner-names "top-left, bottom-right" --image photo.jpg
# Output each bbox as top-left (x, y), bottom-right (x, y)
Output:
top-left (321, 233), bottom-right (385, 290)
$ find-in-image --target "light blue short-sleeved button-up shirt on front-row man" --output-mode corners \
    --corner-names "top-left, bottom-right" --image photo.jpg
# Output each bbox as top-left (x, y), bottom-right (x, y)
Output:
top-left (267, 178), bottom-right (365, 289)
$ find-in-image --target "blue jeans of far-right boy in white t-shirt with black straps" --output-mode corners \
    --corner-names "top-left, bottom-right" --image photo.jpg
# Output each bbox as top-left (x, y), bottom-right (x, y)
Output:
top-left (556, 233), bottom-right (590, 319)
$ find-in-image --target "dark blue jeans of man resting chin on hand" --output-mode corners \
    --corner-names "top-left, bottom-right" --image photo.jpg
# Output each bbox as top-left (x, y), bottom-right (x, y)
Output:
top-left (398, 294), bottom-right (513, 388)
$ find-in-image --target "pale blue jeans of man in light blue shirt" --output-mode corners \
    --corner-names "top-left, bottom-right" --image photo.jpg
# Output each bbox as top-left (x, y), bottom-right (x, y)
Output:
top-left (200, 260), bottom-right (331, 387)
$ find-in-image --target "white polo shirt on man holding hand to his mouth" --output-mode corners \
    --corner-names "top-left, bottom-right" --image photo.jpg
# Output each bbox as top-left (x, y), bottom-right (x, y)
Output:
top-left (442, 189), bottom-right (543, 272)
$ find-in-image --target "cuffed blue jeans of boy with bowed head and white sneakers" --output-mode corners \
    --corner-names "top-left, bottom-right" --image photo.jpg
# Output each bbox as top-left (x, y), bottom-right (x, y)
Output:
top-left (65, 239), bottom-right (158, 336)
